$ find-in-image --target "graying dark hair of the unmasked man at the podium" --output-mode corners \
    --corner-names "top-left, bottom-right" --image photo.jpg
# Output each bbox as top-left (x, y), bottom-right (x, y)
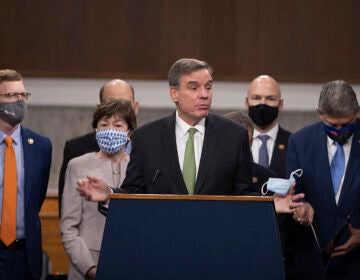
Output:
top-left (168, 58), bottom-right (213, 89)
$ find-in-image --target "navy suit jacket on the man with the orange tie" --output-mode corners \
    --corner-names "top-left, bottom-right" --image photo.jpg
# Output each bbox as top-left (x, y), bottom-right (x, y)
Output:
top-left (21, 126), bottom-right (52, 278)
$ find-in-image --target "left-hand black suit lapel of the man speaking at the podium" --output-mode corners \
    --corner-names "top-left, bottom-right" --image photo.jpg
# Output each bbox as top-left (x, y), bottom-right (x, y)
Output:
top-left (161, 113), bottom-right (188, 194)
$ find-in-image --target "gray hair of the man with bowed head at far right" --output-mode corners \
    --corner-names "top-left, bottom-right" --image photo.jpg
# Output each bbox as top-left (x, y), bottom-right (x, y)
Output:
top-left (318, 80), bottom-right (359, 117)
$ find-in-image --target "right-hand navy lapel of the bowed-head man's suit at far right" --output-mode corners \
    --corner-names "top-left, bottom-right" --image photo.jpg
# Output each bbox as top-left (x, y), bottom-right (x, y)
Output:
top-left (338, 119), bottom-right (360, 206)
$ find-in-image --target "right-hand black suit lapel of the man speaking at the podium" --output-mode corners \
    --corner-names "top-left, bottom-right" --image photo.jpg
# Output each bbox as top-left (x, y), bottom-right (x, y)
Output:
top-left (195, 115), bottom-right (217, 193)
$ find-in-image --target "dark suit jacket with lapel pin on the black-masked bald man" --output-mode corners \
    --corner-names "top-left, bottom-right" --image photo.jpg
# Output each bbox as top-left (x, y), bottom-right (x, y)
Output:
top-left (269, 126), bottom-right (291, 178)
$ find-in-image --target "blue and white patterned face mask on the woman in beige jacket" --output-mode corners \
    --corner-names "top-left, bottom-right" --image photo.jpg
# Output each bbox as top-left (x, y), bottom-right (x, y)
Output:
top-left (96, 129), bottom-right (128, 155)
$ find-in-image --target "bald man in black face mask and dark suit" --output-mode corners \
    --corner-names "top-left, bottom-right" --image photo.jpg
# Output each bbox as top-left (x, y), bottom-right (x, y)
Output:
top-left (245, 75), bottom-right (297, 279)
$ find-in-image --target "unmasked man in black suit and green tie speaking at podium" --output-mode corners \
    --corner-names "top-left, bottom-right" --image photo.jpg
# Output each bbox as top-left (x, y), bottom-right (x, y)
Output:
top-left (78, 58), bottom-right (254, 201)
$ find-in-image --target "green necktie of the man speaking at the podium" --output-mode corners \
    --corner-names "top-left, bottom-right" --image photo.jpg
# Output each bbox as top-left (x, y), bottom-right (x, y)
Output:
top-left (183, 127), bottom-right (196, 194)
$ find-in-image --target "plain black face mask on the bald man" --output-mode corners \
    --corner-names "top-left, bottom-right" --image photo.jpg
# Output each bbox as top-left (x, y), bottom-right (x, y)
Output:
top-left (249, 104), bottom-right (279, 128)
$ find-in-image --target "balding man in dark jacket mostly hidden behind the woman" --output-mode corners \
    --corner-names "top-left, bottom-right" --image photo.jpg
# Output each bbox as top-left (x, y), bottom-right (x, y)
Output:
top-left (58, 79), bottom-right (139, 217)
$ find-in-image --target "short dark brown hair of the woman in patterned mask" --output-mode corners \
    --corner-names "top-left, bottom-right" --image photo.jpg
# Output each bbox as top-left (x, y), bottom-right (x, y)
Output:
top-left (92, 99), bottom-right (137, 132)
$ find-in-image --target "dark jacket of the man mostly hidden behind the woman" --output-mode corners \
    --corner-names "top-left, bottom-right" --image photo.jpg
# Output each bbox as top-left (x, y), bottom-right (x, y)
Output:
top-left (58, 132), bottom-right (100, 217)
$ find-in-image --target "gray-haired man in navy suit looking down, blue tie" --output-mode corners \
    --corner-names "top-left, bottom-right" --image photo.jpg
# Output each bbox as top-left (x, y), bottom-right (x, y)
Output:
top-left (287, 80), bottom-right (360, 279)
